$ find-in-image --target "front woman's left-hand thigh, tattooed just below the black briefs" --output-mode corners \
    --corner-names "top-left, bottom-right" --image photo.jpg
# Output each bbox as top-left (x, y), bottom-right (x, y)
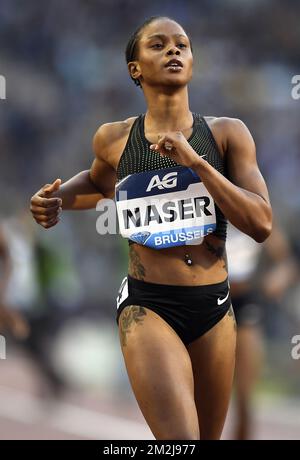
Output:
top-left (119, 305), bottom-right (199, 439)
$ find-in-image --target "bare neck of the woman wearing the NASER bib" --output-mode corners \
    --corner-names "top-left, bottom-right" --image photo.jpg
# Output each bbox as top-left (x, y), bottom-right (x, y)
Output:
top-left (144, 86), bottom-right (193, 131)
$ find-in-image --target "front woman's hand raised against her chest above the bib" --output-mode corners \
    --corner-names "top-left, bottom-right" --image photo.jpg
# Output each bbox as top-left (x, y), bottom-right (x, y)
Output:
top-left (150, 131), bottom-right (201, 168)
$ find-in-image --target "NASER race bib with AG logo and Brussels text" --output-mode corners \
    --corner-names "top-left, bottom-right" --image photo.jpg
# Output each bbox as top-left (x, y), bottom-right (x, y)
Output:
top-left (116, 166), bottom-right (216, 249)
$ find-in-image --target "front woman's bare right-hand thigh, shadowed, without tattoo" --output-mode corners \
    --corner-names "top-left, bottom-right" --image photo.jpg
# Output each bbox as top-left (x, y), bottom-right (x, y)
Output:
top-left (187, 307), bottom-right (236, 439)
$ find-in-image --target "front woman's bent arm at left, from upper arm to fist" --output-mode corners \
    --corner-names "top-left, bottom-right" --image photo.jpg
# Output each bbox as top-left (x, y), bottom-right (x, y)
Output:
top-left (30, 125), bottom-right (116, 228)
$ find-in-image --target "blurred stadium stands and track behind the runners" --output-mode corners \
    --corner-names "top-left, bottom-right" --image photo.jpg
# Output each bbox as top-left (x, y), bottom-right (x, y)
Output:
top-left (0, 0), bottom-right (300, 439)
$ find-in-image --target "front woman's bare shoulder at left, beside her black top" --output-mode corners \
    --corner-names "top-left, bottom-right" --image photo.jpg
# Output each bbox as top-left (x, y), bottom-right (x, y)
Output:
top-left (93, 117), bottom-right (137, 160)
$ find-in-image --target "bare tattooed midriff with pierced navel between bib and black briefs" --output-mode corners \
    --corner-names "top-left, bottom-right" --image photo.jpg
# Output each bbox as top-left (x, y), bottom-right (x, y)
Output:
top-left (128, 235), bottom-right (227, 286)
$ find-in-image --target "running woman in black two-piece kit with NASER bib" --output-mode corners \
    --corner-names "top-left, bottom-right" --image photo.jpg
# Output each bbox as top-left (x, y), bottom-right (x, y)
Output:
top-left (31, 17), bottom-right (272, 440)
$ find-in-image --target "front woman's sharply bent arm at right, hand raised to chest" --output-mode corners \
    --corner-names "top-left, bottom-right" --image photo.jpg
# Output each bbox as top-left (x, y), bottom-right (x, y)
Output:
top-left (152, 119), bottom-right (272, 243)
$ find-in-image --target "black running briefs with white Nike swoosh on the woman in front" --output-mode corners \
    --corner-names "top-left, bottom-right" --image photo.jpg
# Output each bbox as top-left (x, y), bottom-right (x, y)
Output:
top-left (116, 275), bottom-right (231, 345)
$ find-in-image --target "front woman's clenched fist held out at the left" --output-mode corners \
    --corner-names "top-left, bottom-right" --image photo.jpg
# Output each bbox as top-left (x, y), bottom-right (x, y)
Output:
top-left (30, 179), bottom-right (62, 228)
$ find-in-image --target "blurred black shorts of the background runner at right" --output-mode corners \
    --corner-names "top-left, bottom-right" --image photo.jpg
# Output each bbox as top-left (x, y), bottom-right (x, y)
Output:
top-left (231, 291), bottom-right (263, 327)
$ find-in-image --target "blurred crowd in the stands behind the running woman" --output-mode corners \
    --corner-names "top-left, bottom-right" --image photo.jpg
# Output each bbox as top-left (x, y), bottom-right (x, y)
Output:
top-left (0, 0), bottom-right (300, 438)
